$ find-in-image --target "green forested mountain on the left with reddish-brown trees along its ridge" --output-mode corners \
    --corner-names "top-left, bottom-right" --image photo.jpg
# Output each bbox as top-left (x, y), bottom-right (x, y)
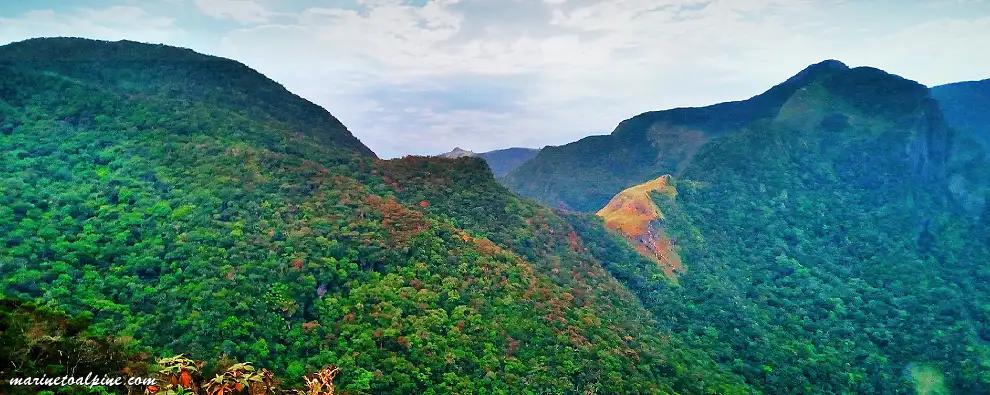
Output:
top-left (0, 38), bottom-right (751, 393)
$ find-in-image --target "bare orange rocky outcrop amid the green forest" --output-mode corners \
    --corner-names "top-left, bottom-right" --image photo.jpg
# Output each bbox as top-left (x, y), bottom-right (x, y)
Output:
top-left (596, 175), bottom-right (685, 281)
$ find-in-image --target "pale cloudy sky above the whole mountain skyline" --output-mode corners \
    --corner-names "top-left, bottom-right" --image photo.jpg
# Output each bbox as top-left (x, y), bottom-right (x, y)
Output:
top-left (0, 0), bottom-right (990, 158)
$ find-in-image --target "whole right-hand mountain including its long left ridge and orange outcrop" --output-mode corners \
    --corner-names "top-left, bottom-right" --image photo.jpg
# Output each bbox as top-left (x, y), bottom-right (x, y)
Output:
top-left (505, 62), bottom-right (990, 393)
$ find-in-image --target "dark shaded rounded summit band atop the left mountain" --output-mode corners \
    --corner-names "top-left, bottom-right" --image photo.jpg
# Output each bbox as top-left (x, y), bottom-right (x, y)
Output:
top-left (0, 37), bottom-right (375, 157)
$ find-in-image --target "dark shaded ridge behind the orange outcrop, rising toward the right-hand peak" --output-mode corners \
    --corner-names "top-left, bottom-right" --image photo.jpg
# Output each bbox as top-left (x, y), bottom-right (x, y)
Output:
top-left (505, 60), bottom-right (848, 212)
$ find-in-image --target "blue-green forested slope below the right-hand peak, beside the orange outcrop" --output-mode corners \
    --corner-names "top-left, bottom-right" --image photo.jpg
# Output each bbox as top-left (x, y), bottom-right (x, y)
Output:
top-left (564, 68), bottom-right (990, 393)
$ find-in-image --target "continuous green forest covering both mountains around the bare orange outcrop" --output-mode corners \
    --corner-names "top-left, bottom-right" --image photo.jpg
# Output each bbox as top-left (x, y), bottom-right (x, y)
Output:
top-left (0, 39), bottom-right (990, 394)
